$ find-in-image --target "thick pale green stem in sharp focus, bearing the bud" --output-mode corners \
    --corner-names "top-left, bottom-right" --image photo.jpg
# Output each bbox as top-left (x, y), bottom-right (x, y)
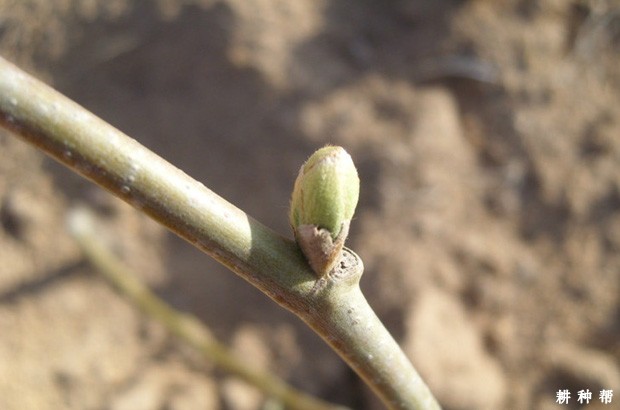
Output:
top-left (0, 58), bottom-right (439, 409)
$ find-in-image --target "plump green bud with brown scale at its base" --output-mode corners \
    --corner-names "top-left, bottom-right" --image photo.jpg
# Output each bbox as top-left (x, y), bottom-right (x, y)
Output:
top-left (289, 146), bottom-right (360, 276)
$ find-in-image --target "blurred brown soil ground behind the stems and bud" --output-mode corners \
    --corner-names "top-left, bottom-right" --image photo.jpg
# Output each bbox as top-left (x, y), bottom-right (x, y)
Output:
top-left (0, 0), bottom-right (620, 410)
